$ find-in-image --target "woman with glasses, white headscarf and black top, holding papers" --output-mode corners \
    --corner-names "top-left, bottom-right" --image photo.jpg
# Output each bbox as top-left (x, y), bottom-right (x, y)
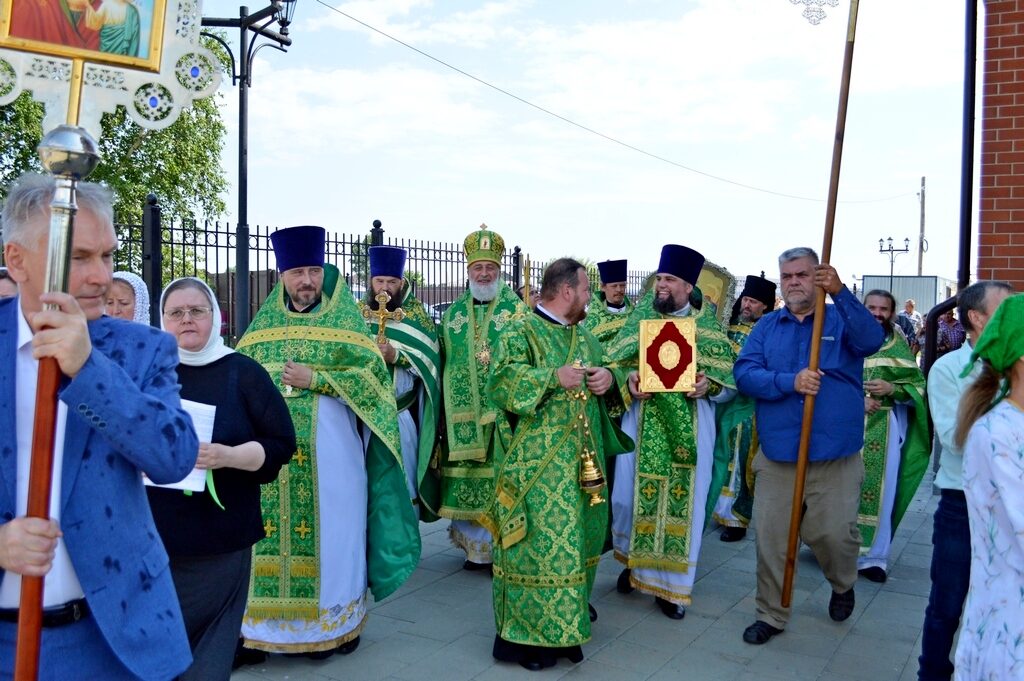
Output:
top-left (148, 278), bottom-right (295, 681)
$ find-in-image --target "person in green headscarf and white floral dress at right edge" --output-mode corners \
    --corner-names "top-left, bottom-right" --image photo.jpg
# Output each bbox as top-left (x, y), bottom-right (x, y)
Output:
top-left (954, 294), bottom-right (1024, 681)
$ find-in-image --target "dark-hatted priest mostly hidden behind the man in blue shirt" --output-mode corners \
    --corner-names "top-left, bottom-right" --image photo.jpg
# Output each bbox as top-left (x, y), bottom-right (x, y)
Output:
top-left (708, 274), bottom-right (775, 542)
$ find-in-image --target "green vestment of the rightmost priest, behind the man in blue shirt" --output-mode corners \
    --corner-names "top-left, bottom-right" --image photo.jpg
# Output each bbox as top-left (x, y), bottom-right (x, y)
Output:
top-left (857, 333), bottom-right (932, 547)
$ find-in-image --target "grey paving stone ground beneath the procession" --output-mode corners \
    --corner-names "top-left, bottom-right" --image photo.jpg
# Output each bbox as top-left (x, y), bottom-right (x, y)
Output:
top-left (231, 473), bottom-right (938, 681)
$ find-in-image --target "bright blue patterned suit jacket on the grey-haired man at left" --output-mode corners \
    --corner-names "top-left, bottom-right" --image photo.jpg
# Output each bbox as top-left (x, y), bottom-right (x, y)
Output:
top-left (0, 298), bottom-right (199, 679)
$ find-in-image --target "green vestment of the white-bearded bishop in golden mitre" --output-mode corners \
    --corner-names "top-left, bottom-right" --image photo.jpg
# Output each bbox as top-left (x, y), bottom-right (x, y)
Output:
top-left (437, 285), bottom-right (529, 521)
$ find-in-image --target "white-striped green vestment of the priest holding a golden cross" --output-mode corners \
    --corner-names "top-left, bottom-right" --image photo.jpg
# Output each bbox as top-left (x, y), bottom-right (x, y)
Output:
top-left (367, 280), bottom-right (441, 522)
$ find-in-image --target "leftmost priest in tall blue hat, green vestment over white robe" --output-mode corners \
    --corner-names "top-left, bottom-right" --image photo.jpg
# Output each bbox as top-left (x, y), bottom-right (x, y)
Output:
top-left (237, 226), bottom-right (420, 658)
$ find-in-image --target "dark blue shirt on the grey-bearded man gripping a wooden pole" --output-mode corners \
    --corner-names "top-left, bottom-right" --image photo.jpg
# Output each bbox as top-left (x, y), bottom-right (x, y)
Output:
top-left (732, 287), bottom-right (885, 462)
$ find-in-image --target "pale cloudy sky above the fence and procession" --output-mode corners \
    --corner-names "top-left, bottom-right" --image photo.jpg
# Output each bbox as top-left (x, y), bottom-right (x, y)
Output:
top-left (203, 0), bottom-right (983, 283)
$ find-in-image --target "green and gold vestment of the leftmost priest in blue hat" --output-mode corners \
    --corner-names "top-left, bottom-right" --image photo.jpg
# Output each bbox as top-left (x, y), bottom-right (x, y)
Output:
top-left (236, 265), bottom-right (420, 620)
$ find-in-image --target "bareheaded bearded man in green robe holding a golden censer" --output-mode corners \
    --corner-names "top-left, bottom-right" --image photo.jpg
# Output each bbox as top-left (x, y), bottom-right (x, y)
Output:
top-left (485, 258), bottom-right (633, 671)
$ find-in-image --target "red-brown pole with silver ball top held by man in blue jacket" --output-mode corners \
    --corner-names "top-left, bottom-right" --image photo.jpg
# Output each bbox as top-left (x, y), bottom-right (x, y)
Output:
top-left (14, 125), bottom-right (99, 681)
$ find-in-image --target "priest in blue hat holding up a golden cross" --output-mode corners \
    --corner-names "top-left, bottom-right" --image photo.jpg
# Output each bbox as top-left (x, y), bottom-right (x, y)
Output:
top-left (361, 246), bottom-right (441, 520)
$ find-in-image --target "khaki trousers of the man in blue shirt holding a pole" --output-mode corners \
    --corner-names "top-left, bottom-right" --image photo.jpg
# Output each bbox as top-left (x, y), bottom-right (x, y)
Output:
top-left (753, 450), bottom-right (864, 629)
